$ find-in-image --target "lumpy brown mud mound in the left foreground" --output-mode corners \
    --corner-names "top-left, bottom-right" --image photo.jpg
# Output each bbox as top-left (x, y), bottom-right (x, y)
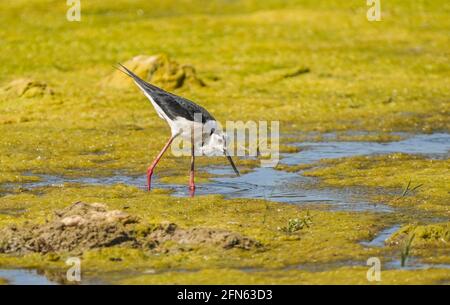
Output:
top-left (0, 202), bottom-right (261, 254)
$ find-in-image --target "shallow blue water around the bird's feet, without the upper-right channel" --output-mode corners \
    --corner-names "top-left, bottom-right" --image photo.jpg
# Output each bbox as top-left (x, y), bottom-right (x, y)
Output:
top-left (13, 167), bottom-right (392, 212)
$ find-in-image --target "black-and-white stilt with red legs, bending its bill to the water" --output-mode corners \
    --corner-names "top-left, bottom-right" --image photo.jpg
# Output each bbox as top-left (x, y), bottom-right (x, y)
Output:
top-left (119, 64), bottom-right (239, 194)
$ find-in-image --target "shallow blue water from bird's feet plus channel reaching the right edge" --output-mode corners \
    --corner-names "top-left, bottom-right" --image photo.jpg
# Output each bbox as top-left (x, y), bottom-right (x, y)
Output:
top-left (14, 133), bottom-right (450, 212)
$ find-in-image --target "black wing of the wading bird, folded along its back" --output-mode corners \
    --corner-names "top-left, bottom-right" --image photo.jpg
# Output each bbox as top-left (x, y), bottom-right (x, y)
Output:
top-left (116, 64), bottom-right (215, 123)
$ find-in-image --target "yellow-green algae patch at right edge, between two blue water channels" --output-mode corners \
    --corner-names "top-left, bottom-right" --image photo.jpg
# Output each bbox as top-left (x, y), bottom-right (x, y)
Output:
top-left (304, 154), bottom-right (450, 216)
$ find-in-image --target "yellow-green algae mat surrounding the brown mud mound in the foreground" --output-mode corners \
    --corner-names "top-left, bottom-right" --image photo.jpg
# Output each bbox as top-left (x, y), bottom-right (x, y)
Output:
top-left (0, 185), bottom-right (390, 280)
